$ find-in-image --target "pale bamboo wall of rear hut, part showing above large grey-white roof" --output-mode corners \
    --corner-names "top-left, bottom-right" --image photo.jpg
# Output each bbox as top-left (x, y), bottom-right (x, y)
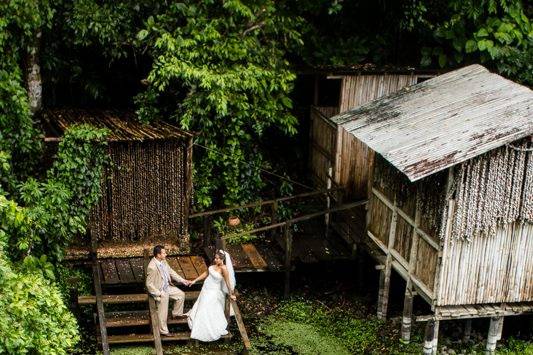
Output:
top-left (340, 74), bottom-right (417, 112)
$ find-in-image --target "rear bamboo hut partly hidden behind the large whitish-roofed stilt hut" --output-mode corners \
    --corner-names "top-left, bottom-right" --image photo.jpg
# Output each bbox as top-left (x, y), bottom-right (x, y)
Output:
top-left (309, 65), bottom-right (436, 247)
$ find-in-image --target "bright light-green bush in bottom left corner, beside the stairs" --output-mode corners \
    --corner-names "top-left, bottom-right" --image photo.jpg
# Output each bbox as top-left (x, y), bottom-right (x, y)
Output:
top-left (0, 196), bottom-right (79, 354)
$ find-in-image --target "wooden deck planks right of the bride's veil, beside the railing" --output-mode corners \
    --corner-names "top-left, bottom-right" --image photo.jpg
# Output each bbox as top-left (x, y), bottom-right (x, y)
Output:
top-left (205, 241), bottom-right (284, 272)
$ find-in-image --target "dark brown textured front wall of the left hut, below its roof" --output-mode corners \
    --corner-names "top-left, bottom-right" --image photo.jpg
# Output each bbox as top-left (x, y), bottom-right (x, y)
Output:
top-left (88, 139), bottom-right (190, 250)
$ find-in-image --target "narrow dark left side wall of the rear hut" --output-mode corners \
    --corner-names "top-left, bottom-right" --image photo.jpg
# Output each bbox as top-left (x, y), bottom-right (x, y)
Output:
top-left (309, 107), bottom-right (338, 186)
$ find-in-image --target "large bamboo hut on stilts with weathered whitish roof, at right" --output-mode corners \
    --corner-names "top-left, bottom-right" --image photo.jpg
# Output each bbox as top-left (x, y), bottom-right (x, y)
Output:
top-left (331, 65), bottom-right (533, 353)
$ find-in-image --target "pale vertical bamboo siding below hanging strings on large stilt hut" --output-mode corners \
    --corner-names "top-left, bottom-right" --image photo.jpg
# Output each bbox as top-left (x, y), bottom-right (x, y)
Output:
top-left (438, 222), bottom-right (533, 305)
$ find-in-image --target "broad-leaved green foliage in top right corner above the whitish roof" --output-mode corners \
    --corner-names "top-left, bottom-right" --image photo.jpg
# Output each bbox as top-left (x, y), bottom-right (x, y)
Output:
top-left (422, 0), bottom-right (533, 84)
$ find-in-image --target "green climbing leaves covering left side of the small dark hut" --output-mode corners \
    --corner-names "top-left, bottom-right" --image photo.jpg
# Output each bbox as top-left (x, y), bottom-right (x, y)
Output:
top-left (12, 125), bottom-right (108, 260)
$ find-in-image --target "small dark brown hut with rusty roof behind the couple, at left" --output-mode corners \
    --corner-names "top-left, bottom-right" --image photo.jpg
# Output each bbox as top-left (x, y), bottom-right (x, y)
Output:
top-left (43, 109), bottom-right (193, 257)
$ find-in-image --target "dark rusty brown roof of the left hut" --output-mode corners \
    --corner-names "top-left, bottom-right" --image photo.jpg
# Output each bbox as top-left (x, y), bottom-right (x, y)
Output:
top-left (43, 109), bottom-right (192, 141)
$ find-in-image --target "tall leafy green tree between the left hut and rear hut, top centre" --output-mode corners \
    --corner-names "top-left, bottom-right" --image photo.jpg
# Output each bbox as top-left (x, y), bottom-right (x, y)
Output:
top-left (136, 0), bottom-right (300, 208)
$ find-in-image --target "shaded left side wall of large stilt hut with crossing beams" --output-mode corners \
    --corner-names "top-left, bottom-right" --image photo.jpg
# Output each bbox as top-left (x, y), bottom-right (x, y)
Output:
top-left (367, 156), bottom-right (447, 301)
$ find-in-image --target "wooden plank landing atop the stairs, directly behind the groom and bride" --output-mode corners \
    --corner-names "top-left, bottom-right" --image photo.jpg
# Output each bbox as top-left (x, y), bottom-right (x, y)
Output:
top-left (98, 255), bottom-right (207, 285)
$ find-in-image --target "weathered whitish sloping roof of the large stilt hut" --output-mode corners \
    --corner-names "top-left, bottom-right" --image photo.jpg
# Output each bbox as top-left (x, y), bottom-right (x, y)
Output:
top-left (331, 65), bottom-right (533, 181)
